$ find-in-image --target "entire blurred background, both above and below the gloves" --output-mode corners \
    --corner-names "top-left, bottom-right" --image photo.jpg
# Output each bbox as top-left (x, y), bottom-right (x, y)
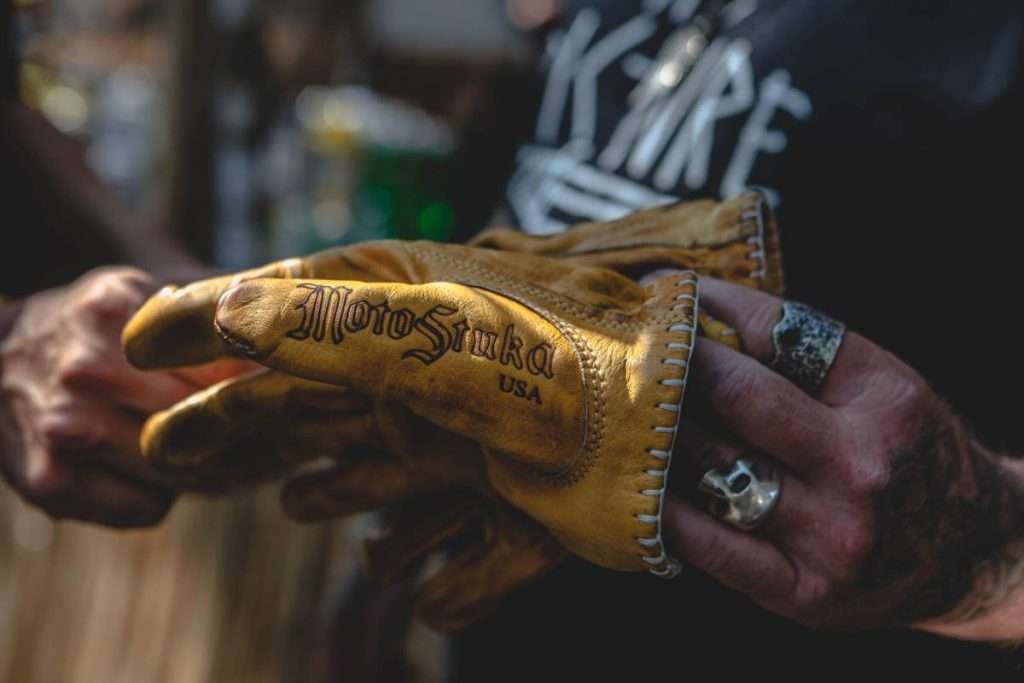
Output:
top-left (0, 0), bottom-right (558, 683)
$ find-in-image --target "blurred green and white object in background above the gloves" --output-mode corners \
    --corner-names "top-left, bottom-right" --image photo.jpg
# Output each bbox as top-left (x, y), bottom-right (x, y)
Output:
top-left (275, 86), bottom-right (455, 256)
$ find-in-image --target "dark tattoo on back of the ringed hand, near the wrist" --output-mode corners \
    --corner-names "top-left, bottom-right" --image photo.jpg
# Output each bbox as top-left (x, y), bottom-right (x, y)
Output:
top-left (865, 411), bottom-right (1024, 623)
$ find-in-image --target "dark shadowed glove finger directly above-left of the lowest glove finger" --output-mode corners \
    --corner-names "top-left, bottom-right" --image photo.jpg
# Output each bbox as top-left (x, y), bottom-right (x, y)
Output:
top-left (362, 493), bottom-right (486, 583)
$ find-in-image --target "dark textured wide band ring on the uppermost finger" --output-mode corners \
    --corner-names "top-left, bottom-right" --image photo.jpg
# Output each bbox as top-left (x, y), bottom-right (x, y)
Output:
top-left (768, 301), bottom-right (846, 396)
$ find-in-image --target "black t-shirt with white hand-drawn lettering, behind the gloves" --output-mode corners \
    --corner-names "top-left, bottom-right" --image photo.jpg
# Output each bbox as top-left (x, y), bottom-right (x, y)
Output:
top-left (459, 0), bottom-right (1024, 681)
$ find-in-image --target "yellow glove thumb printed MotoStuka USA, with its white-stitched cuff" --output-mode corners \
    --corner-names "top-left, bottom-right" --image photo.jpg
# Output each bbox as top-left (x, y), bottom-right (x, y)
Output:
top-left (199, 243), bottom-right (697, 572)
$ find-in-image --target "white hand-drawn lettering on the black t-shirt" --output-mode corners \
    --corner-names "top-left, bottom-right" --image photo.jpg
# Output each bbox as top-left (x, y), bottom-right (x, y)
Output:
top-left (508, 0), bottom-right (812, 233)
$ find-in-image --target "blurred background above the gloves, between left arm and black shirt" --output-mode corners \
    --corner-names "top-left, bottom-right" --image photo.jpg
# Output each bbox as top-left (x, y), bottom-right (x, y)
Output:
top-left (17, 0), bottom-right (536, 267)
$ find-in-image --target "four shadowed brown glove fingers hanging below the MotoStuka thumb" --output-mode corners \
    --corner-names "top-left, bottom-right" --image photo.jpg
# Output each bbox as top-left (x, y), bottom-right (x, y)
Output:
top-left (142, 370), bottom-right (566, 631)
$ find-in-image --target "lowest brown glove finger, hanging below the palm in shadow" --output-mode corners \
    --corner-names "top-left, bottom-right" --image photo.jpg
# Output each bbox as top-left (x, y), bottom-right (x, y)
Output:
top-left (416, 508), bottom-right (568, 631)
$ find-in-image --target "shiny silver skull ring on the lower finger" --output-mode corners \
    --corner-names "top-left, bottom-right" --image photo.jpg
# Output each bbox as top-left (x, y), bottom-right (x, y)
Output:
top-left (699, 457), bottom-right (782, 531)
